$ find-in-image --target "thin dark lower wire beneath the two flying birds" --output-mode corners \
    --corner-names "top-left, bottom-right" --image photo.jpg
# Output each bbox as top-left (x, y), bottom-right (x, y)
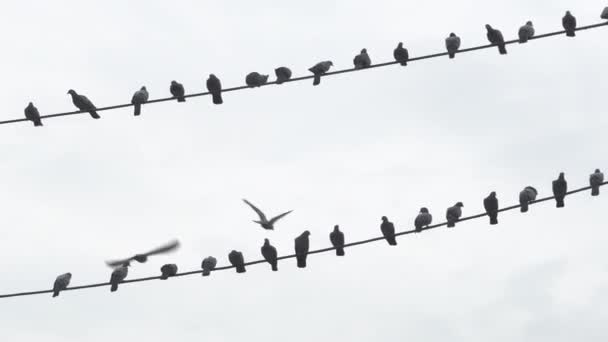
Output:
top-left (0, 181), bottom-right (608, 298)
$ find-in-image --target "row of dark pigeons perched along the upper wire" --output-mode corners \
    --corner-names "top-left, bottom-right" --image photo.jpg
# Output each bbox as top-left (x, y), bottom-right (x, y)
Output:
top-left (19, 7), bottom-right (608, 126)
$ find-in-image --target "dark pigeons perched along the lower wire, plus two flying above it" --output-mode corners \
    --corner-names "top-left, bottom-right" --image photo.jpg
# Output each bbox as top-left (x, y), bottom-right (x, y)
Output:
top-left (47, 169), bottom-right (604, 297)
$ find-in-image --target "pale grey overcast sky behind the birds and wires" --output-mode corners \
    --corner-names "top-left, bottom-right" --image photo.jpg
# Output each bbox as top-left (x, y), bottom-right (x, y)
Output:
top-left (0, 0), bottom-right (608, 342)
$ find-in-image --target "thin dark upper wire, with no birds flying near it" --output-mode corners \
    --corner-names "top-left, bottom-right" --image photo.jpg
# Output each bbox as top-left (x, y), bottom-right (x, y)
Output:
top-left (0, 22), bottom-right (608, 125)
